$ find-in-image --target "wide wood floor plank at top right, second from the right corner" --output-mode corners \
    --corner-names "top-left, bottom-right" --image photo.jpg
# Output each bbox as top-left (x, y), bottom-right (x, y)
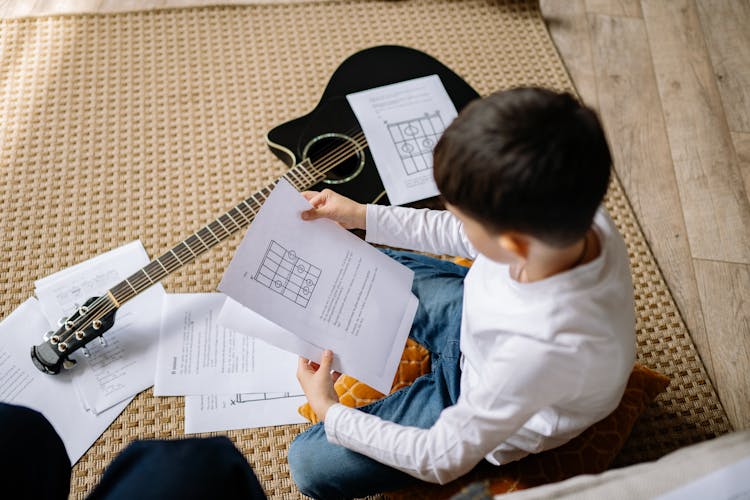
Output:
top-left (642, 0), bottom-right (750, 263)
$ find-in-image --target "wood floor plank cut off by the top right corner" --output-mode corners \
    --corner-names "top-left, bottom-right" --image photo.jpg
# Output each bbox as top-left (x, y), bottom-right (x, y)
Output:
top-left (697, 0), bottom-right (750, 132)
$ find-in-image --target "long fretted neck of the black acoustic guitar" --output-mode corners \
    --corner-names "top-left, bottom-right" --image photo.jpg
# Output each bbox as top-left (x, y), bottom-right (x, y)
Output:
top-left (107, 161), bottom-right (325, 307)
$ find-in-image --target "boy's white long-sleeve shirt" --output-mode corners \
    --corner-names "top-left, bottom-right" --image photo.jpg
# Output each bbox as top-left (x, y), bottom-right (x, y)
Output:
top-left (325, 205), bottom-right (635, 484)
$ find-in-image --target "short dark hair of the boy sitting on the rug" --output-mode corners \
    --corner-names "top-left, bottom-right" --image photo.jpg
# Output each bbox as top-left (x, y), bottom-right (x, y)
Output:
top-left (434, 88), bottom-right (612, 247)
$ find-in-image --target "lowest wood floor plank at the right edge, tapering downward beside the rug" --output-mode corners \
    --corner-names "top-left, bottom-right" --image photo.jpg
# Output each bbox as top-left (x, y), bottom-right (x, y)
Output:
top-left (694, 259), bottom-right (750, 429)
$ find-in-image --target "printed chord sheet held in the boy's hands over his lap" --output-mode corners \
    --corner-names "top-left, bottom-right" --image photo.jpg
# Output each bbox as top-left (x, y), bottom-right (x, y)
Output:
top-left (219, 179), bottom-right (417, 393)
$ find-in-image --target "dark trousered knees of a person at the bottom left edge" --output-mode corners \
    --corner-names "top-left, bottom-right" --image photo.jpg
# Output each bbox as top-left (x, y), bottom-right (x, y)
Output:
top-left (0, 403), bottom-right (266, 500)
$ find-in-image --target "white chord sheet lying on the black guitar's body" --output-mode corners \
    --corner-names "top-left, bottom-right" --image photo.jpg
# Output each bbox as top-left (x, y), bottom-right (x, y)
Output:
top-left (346, 75), bottom-right (457, 205)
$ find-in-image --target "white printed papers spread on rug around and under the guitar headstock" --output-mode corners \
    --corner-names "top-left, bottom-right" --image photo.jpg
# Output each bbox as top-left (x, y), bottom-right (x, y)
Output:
top-left (0, 241), bottom-right (304, 463)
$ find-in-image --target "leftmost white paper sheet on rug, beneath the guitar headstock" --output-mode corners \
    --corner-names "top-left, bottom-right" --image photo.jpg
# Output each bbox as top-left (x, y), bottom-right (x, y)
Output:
top-left (0, 298), bottom-right (132, 464)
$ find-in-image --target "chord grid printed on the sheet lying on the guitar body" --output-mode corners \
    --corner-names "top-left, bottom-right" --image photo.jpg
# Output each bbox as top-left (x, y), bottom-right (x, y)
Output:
top-left (386, 111), bottom-right (445, 175)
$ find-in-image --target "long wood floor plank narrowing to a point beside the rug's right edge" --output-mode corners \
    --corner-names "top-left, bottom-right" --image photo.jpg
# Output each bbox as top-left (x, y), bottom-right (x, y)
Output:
top-left (589, 15), bottom-right (712, 376)
